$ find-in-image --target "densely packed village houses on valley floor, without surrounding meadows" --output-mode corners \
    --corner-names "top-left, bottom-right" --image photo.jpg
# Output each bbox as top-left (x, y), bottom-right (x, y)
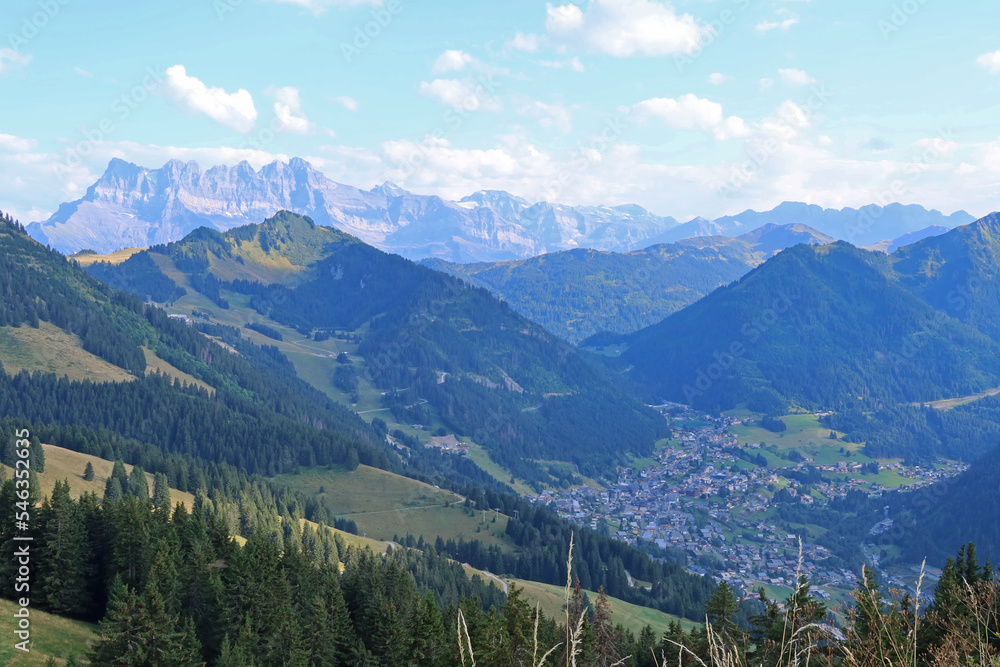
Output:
top-left (532, 415), bottom-right (965, 597)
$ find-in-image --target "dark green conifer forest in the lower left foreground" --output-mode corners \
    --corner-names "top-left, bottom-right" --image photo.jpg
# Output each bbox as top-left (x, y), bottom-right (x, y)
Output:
top-left (0, 480), bottom-right (504, 667)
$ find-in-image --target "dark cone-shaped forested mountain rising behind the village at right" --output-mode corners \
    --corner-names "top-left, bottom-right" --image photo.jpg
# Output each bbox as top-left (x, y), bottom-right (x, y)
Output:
top-left (622, 242), bottom-right (1000, 412)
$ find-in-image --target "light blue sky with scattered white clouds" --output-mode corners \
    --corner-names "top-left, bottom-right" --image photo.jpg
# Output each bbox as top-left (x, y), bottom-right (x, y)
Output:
top-left (0, 0), bottom-right (1000, 222)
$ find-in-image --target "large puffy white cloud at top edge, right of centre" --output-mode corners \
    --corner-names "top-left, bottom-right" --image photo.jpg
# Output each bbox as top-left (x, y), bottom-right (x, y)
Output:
top-left (545, 0), bottom-right (708, 58)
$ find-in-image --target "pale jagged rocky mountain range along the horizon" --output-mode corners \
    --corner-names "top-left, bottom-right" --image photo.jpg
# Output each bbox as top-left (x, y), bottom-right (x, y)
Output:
top-left (28, 158), bottom-right (973, 262)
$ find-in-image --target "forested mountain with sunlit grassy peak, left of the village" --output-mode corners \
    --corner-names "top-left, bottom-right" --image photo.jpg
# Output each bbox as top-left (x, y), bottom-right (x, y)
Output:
top-left (88, 212), bottom-right (665, 480)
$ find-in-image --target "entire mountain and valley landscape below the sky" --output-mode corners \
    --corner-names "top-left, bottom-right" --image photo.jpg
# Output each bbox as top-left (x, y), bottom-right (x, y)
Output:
top-left (0, 159), bottom-right (1000, 667)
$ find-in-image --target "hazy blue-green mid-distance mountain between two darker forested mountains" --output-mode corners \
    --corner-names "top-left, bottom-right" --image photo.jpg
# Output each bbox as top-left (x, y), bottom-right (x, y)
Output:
top-left (423, 224), bottom-right (834, 343)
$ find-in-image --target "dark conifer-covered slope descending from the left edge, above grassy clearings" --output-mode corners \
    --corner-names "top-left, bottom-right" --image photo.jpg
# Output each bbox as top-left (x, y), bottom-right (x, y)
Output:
top-left (0, 211), bottom-right (410, 474)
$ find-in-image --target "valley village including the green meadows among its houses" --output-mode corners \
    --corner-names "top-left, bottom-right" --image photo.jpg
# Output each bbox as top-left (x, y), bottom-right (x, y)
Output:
top-left (532, 405), bottom-right (968, 600)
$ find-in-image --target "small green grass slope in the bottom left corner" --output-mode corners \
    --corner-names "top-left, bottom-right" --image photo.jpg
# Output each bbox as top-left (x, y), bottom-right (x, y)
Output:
top-left (0, 598), bottom-right (97, 667)
